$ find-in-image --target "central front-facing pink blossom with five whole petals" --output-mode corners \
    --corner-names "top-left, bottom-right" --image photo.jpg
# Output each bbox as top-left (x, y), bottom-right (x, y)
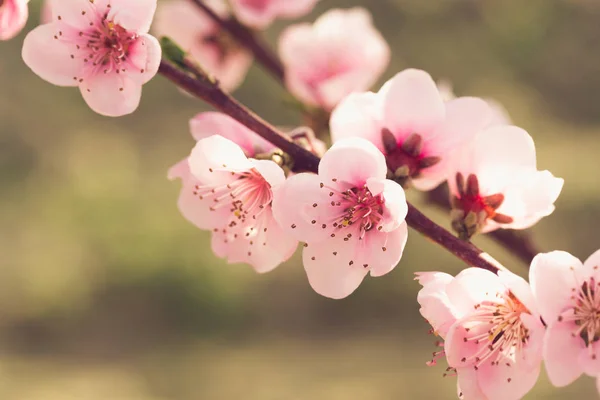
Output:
top-left (273, 138), bottom-right (408, 299)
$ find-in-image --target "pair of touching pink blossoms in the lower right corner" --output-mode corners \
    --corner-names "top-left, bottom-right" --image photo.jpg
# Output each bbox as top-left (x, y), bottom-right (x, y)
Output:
top-left (416, 250), bottom-right (600, 400)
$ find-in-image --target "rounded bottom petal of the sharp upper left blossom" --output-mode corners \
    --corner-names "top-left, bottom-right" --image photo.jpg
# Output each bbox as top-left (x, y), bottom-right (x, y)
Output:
top-left (79, 73), bottom-right (142, 117)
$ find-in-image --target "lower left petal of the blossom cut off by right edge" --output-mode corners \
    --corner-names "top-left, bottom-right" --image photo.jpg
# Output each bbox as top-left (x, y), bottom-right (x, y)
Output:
top-left (544, 321), bottom-right (586, 387)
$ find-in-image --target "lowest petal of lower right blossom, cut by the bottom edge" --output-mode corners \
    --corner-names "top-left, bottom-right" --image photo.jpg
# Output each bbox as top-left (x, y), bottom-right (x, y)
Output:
top-left (477, 358), bottom-right (541, 400)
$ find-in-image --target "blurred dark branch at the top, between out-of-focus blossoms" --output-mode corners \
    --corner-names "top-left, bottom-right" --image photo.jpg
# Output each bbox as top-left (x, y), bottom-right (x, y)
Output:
top-left (191, 0), bottom-right (284, 82)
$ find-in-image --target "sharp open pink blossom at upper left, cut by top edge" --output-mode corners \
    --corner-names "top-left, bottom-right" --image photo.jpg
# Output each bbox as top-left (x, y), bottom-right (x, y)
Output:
top-left (23, 0), bottom-right (161, 117)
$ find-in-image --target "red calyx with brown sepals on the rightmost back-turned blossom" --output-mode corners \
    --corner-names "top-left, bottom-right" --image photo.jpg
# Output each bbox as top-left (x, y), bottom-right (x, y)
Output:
top-left (452, 172), bottom-right (513, 239)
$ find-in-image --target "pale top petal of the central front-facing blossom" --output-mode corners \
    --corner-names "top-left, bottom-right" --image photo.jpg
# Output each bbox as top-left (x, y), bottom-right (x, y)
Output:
top-left (319, 138), bottom-right (387, 186)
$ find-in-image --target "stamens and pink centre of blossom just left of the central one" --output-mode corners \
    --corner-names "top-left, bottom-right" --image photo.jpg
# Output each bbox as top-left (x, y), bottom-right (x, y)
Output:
top-left (194, 169), bottom-right (273, 228)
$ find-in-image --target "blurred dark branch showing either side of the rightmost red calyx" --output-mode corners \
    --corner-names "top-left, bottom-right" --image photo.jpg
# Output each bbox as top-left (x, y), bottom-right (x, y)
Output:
top-left (427, 185), bottom-right (539, 265)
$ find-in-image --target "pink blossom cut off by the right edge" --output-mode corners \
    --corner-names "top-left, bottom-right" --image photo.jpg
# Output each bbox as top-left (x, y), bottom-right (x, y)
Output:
top-left (529, 251), bottom-right (600, 390)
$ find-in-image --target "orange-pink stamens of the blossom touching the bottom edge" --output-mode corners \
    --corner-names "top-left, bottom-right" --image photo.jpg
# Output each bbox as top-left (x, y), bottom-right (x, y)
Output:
top-left (461, 291), bottom-right (530, 369)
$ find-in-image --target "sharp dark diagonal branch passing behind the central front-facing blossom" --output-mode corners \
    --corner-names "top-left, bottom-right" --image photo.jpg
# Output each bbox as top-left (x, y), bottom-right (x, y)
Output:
top-left (159, 61), bottom-right (502, 272)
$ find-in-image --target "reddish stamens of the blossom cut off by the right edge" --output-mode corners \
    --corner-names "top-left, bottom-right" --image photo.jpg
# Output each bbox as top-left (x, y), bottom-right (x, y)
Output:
top-left (558, 277), bottom-right (600, 347)
